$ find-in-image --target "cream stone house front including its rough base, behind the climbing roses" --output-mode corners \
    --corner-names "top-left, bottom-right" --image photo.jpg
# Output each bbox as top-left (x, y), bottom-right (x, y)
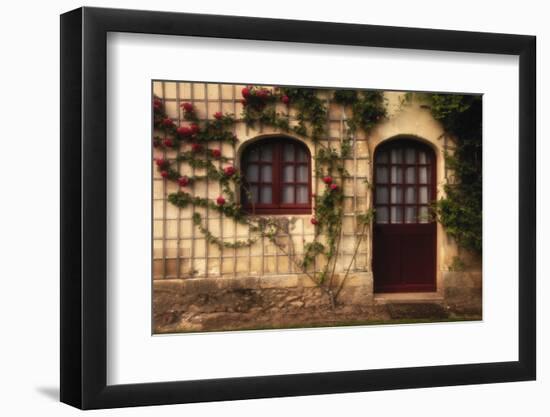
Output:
top-left (153, 81), bottom-right (481, 331)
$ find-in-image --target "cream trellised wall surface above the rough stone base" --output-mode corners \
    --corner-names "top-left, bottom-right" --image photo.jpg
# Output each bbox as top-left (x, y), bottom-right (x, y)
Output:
top-left (153, 82), bottom-right (470, 296)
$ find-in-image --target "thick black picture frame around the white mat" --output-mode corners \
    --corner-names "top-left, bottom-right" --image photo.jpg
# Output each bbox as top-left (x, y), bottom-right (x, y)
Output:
top-left (60, 7), bottom-right (536, 409)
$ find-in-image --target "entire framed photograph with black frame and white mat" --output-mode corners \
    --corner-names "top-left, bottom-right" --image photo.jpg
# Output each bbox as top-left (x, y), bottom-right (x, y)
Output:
top-left (61, 7), bottom-right (536, 409)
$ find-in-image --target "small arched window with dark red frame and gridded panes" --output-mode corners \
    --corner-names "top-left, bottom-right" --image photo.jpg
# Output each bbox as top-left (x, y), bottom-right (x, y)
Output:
top-left (241, 137), bottom-right (311, 214)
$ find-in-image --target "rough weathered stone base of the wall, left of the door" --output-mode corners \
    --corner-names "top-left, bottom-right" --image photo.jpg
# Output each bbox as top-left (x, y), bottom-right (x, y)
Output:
top-left (153, 272), bottom-right (373, 333)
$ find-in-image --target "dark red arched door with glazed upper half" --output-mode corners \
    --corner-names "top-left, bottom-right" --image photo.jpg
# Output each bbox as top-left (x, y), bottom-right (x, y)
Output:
top-left (373, 139), bottom-right (436, 292)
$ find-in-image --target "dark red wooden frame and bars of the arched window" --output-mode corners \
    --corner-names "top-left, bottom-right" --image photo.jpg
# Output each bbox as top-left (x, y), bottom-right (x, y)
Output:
top-left (240, 136), bottom-right (313, 214)
